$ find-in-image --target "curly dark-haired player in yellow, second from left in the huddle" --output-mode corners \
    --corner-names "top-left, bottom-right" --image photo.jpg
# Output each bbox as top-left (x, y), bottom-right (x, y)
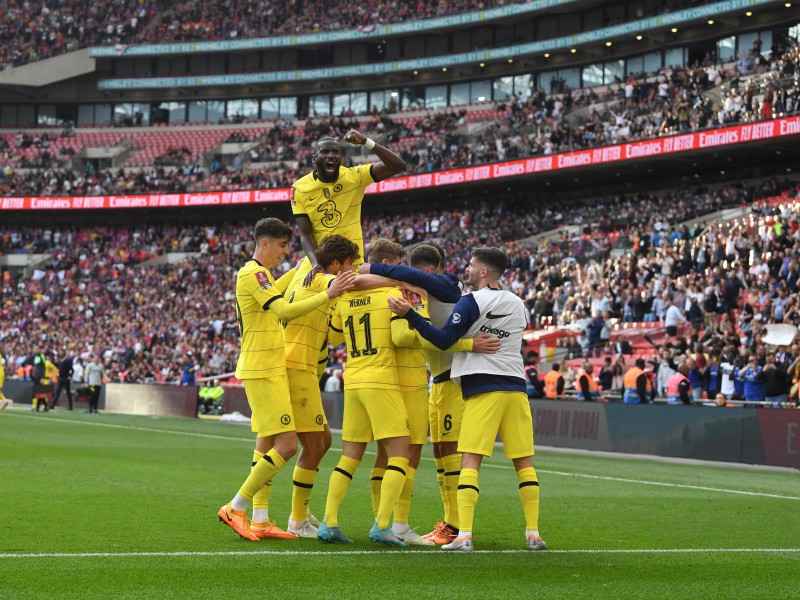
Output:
top-left (283, 235), bottom-right (360, 538)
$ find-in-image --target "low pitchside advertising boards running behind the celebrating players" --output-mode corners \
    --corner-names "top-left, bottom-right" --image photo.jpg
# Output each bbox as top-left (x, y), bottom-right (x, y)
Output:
top-left (3, 380), bottom-right (800, 469)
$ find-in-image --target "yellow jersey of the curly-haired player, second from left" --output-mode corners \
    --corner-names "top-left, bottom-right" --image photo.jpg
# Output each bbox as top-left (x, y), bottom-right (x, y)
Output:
top-left (283, 264), bottom-right (334, 373)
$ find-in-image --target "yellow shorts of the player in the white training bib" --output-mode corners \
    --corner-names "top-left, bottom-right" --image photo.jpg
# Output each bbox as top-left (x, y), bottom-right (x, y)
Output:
top-left (458, 392), bottom-right (533, 458)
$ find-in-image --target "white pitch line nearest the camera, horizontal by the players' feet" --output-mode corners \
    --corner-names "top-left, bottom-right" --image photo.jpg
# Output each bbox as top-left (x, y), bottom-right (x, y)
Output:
top-left (0, 548), bottom-right (800, 559)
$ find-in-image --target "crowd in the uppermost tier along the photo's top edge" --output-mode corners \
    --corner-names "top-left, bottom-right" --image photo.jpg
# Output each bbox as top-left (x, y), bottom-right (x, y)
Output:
top-left (0, 0), bottom-right (720, 70)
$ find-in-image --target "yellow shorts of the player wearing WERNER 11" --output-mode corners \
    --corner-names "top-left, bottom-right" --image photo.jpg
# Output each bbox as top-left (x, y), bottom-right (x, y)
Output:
top-left (342, 389), bottom-right (409, 442)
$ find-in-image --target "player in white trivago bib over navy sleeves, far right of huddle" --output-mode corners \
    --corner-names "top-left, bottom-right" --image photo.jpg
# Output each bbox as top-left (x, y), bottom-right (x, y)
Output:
top-left (388, 248), bottom-right (547, 552)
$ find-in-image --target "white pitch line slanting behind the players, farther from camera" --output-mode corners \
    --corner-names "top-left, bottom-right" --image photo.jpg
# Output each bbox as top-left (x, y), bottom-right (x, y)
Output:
top-left (6, 414), bottom-right (800, 500)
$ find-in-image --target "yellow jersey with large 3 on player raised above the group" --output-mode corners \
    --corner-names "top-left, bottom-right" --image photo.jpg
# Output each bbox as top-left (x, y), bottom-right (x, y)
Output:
top-left (292, 165), bottom-right (375, 264)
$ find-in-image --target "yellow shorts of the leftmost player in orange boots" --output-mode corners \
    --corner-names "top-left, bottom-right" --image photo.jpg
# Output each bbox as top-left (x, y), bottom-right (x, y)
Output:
top-left (242, 375), bottom-right (295, 437)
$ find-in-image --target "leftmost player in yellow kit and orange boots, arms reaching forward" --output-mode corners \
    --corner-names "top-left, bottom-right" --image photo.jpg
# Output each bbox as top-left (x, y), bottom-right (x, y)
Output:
top-left (217, 218), bottom-right (355, 540)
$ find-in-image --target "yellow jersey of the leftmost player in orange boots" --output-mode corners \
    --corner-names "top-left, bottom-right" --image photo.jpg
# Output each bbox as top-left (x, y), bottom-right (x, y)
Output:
top-left (236, 260), bottom-right (286, 379)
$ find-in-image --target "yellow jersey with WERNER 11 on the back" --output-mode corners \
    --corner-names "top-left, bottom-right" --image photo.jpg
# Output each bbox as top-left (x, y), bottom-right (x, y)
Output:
top-left (331, 287), bottom-right (401, 390)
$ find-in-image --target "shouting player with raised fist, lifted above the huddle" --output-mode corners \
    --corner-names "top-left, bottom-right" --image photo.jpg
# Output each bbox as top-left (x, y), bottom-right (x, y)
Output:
top-left (291, 129), bottom-right (406, 285)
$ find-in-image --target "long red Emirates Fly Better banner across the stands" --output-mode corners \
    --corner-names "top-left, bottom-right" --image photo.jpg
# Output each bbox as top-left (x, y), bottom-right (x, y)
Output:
top-left (0, 116), bottom-right (800, 210)
